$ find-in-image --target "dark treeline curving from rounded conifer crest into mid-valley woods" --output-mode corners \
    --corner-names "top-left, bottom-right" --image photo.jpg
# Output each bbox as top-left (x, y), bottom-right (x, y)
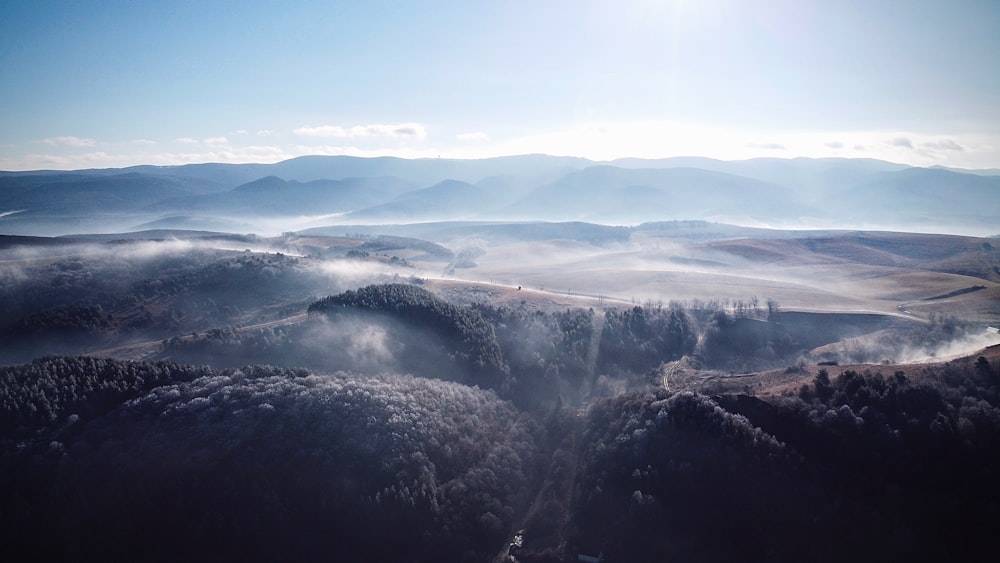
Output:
top-left (309, 284), bottom-right (804, 384)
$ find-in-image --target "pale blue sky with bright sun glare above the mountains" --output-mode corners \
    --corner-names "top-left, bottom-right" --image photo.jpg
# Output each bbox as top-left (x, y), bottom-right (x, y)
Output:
top-left (0, 0), bottom-right (1000, 170)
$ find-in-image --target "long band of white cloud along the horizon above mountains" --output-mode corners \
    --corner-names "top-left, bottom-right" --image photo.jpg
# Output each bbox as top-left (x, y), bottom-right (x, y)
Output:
top-left (0, 120), bottom-right (1000, 170)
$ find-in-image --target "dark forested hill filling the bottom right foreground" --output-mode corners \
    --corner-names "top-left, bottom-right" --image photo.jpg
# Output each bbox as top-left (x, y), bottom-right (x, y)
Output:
top-left (564, 358), bottom-right (1000, 562)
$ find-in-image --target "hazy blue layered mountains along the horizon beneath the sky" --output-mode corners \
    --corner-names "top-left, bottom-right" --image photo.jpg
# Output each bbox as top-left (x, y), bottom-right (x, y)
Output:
top-left (0, 155), bottom-right (1000, 235)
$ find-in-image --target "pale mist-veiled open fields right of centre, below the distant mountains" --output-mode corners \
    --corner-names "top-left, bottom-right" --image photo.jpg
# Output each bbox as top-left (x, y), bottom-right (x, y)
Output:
top-left (438, 226), bottom-right (1000, 323)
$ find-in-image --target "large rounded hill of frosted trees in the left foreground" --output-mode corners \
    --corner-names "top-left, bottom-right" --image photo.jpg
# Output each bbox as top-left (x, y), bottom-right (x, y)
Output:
top-left (0, 359), bottom-right (544, 561)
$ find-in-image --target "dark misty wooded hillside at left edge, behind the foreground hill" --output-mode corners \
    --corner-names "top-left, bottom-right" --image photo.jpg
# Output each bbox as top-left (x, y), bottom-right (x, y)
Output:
top-left (0, 241), bottom-right (337, 362)
